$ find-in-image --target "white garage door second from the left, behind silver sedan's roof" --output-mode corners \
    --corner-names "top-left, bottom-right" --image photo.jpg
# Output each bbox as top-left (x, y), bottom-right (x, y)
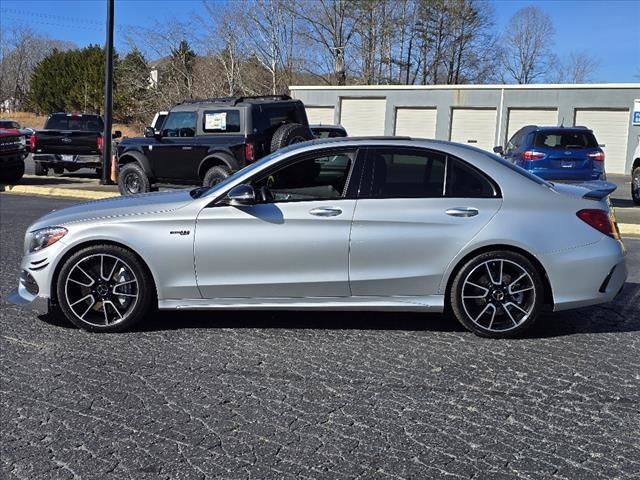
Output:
top-left (340, 98), bottom-right (387, 137)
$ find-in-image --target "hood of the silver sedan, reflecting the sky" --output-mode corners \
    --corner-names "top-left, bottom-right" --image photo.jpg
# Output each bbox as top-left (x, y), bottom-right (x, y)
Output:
top-left (29, 190), bottom-right (193, 231)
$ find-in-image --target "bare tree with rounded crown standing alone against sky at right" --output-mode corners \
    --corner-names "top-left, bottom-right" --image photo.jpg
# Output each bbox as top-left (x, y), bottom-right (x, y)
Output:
top-left (501, 7), bottom-right (554, 84)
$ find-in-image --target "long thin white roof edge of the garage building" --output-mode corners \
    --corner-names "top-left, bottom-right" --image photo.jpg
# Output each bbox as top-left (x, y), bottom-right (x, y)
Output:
top-left (289, 83), bottom-right (640, 91)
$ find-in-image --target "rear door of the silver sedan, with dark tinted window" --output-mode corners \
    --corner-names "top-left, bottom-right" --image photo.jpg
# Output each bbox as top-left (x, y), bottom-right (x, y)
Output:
top-left (349, 147), bottom-right (502, 296)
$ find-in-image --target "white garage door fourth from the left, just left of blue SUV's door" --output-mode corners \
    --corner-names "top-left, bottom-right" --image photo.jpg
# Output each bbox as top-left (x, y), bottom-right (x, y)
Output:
top-left (451, 108), bottom-right (496, 151)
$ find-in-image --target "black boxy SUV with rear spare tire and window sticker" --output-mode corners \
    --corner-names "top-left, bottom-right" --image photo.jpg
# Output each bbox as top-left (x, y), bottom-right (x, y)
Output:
top-left (118, 95), bottom-right (314, 195)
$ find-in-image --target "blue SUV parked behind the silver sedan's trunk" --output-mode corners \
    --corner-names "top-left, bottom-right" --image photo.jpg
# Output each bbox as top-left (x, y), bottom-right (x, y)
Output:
top-left (493, 125), bottom-right (606, 181)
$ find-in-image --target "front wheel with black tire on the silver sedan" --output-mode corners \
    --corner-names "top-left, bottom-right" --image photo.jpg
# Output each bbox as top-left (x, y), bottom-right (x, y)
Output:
top-left (56, 245), bottom-right (156, 332)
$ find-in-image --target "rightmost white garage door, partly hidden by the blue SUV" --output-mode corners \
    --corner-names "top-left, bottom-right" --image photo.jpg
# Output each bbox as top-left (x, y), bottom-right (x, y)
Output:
top-left (575, 110), bottom-right (629, 173)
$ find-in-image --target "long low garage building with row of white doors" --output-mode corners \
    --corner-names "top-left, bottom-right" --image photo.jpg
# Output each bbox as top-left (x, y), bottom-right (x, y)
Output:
top-left (290, 83), bottom-right (640, 173)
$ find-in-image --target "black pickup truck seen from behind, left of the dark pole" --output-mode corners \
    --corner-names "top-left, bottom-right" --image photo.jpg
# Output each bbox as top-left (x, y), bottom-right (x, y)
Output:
top-left (29, 113), bottom-right (122, 175)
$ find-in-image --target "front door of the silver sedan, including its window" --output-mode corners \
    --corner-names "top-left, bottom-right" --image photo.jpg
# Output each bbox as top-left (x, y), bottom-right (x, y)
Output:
top-left (195, 151), bottom-right (356, 299)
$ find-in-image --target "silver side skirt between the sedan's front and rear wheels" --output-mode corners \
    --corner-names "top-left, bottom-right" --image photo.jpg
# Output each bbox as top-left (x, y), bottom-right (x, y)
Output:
top-left (158, 295), bottom-right (444, 312)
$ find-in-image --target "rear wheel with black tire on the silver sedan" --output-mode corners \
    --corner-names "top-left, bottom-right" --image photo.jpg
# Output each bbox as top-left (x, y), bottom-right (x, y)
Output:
top-left (449, 250), bottom-right (544, 338)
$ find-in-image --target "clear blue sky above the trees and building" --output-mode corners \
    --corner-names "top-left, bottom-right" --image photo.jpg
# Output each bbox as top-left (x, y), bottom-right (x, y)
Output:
top-left (0, 0), bottom-right (640, 82)
